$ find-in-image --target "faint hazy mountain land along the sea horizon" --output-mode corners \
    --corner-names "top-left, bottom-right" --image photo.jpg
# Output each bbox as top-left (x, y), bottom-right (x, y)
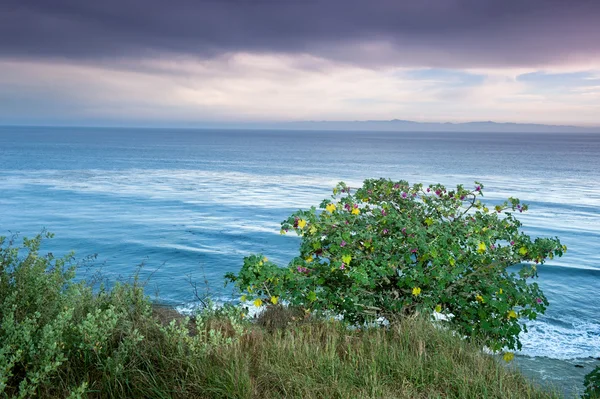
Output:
top-left (207, 119), bottom-right (600, 133)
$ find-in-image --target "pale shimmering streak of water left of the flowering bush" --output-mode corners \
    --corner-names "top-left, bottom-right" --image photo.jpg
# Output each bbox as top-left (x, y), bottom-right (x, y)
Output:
top-left (3, 169), bottom-right (338, 208)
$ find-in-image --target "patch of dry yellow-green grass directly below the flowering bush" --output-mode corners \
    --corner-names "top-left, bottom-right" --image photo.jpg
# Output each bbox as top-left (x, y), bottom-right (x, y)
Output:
top-left (148, 312), bottom-right (558, 398)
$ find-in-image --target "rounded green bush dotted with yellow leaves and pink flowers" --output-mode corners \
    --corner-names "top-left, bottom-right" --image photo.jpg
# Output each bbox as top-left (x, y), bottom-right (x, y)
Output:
top-left (226, 179), bottom-right (566, 354)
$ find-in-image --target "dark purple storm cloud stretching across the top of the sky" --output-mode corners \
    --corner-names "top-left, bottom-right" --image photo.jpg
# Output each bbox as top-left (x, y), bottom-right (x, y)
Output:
top-left (0, 0), bottom-right (600, 67)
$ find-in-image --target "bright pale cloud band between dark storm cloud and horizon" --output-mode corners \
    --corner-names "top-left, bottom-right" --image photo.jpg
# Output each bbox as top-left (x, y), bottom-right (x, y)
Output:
top-left (0, 53), bottom-right (600, 126)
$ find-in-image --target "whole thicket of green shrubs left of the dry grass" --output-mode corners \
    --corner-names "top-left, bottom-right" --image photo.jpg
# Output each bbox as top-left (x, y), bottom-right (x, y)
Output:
top-left (0, 234), bottom-right (248, 398)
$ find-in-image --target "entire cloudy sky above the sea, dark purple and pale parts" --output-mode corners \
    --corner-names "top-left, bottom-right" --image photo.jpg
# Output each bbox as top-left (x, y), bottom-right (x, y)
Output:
top-left (0, 0), bottom-right (600, 126)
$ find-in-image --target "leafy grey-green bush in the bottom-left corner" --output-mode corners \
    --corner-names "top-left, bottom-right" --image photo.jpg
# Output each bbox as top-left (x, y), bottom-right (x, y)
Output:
top-left (0, 234), bottom-right (151, 398)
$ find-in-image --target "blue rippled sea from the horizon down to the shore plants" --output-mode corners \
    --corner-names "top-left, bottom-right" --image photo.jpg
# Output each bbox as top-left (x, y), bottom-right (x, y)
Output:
top-left (0, 128), bottom-right (600, 392)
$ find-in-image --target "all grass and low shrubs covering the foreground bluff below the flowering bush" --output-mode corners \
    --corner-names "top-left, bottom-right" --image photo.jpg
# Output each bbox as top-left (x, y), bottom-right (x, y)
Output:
top-left (0, 239), bottom-right (558, 399)
